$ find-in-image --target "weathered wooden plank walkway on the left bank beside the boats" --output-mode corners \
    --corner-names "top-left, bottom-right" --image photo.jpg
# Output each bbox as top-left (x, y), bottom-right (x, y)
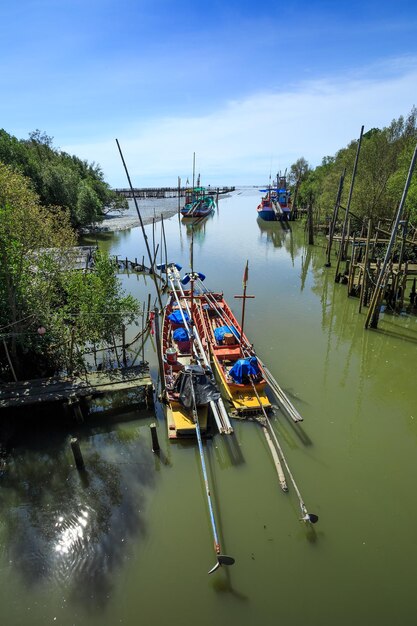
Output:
top-left (0, 366), bottom-right (152, 408)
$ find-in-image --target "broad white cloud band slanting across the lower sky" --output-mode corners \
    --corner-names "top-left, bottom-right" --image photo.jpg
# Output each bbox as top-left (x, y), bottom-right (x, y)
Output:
top-left (63, 58), bottom-right (417, 187)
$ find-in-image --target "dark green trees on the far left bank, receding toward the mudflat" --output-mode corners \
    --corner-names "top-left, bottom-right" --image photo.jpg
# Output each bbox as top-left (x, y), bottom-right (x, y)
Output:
top-left (0, 130), bottom-right (127, 229)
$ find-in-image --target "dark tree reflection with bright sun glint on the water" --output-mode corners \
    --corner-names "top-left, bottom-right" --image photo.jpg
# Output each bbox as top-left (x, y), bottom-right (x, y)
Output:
top-left (0, 425), bottom-right (154, 610)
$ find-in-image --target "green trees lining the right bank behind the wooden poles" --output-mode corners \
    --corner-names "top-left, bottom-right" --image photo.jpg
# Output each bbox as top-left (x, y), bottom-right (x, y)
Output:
top-left (290, 107), bottom-right (417, 227)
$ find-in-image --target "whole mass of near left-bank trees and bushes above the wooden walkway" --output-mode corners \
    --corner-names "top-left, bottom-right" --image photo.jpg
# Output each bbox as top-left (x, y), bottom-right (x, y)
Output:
top-left (0, 162), bottom-right (139, 381)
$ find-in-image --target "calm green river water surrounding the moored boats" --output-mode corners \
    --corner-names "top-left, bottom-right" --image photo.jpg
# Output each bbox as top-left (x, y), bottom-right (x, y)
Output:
top-left (0, 189), bottom-right (417, 626)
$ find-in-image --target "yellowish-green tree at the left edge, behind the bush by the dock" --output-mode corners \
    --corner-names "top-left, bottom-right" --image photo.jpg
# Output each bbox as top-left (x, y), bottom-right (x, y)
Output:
top-left (0, 162), bottom-right (75, 370)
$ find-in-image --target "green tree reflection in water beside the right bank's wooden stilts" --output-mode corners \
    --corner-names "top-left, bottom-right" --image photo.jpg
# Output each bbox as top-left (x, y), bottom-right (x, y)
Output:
top-left (310, 241), bottom-right (417, 416)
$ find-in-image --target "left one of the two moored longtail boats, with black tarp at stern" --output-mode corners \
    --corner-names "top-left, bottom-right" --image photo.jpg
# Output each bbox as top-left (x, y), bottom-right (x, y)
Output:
top-left (161, 291), bottom-right (220, 439)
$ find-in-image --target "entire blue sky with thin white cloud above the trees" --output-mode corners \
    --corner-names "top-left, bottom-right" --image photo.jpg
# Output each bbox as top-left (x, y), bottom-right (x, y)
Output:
top-left (0, 0), bottom-right (417, 187)
